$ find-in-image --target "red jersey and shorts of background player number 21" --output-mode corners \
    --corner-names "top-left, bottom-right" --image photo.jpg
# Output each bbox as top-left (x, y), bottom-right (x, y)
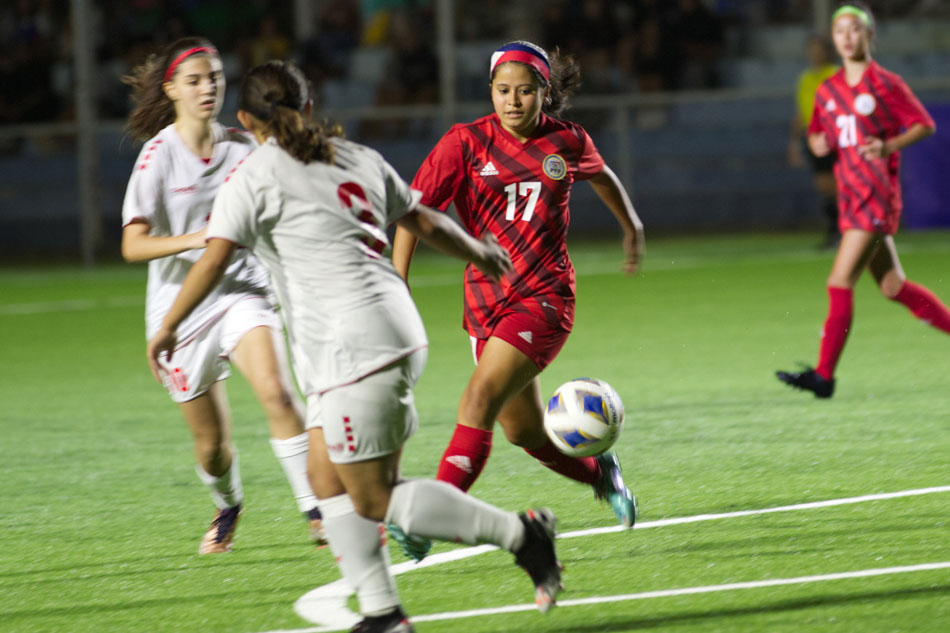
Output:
top-left (808, 61), bottom-right (934, 234)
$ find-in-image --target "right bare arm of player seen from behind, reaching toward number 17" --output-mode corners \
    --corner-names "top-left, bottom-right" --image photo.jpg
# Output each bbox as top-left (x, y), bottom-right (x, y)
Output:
top-left (393, 205), bottom-right (511, 279)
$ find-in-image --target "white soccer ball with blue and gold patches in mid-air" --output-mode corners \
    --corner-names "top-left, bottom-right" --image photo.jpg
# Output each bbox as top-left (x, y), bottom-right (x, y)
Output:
top-left (544, 378), bottom-right (623, 457)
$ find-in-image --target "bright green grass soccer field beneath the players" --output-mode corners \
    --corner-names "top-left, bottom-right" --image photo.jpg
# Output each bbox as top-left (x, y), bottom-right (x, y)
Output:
top-left (0, 233), bottom-right (950, 633)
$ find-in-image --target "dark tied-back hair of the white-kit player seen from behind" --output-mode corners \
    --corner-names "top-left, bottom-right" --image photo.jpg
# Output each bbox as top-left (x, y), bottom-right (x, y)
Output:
top-left (238, 61), bottom-right (342, 163)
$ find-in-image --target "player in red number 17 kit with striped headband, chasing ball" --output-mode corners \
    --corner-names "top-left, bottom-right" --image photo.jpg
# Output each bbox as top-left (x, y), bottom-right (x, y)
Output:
top-left (393, 42), bottom-right (643, 556)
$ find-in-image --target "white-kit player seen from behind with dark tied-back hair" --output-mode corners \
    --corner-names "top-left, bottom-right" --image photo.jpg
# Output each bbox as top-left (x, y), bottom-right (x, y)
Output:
top-left (147, 62), bottom-right (560, 633)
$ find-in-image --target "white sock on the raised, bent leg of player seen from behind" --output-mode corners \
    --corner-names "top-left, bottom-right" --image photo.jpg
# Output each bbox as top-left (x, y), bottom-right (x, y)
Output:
top-left (386, 479), bottom-right (524, 552)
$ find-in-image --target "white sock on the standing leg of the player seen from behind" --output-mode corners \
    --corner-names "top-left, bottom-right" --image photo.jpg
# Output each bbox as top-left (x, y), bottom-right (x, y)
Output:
top-left (320, 494), bottom-right (399, 616)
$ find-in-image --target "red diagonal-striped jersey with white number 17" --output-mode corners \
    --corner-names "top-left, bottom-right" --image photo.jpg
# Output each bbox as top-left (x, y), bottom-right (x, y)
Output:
top-left (412, 114), bottom-right (604, 338)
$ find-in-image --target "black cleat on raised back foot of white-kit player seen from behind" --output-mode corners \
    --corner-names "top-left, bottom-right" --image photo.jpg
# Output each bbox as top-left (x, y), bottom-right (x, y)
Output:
top-left (515, 508), bottom-right (561, 613)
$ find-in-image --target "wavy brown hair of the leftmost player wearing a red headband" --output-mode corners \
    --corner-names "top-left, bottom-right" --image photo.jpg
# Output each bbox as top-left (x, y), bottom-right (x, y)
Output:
top-left (122, 37), bottom-right (214, 141)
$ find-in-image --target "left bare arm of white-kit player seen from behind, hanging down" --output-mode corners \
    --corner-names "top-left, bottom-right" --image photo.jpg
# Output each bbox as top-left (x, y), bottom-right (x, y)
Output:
top-left (145, 238), bottom-right (235, 382)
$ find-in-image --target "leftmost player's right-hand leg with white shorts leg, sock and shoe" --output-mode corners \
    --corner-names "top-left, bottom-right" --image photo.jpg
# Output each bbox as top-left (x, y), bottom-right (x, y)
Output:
top-left (228, 308), bottom-right (325, 544)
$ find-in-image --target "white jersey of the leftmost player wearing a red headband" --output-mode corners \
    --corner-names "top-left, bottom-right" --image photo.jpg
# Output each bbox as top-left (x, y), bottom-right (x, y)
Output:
top-left (122, 123), bottom-right (268, 344)
